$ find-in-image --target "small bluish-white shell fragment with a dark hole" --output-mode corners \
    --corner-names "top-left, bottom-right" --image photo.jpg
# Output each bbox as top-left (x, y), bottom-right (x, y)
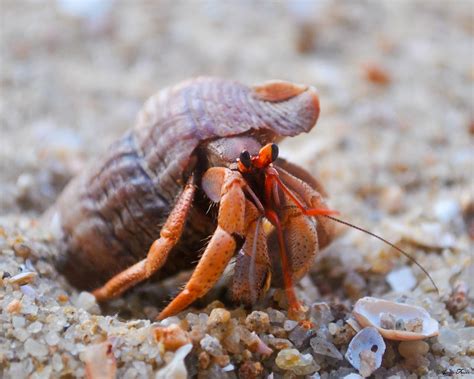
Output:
top-left (346, 327), bottom-right (385, 377)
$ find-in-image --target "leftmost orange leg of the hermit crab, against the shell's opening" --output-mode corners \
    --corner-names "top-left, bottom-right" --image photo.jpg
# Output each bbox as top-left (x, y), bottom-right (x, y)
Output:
top-left (92, 176), bottom-right (195, 301)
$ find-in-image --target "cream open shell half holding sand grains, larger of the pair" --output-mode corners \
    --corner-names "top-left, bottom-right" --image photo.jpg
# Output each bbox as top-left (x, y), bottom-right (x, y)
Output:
top-left (352, 297), bottom-right (439, 341)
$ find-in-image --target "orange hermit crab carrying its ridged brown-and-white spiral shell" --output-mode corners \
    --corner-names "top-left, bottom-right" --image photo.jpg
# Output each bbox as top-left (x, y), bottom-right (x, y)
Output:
top-left (46, 78), bottom-right (331, 316)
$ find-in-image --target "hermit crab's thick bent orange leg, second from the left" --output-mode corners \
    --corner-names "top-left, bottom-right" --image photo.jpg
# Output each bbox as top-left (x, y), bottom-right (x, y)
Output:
top-left (158, 167), bottom-right (246, 320)
